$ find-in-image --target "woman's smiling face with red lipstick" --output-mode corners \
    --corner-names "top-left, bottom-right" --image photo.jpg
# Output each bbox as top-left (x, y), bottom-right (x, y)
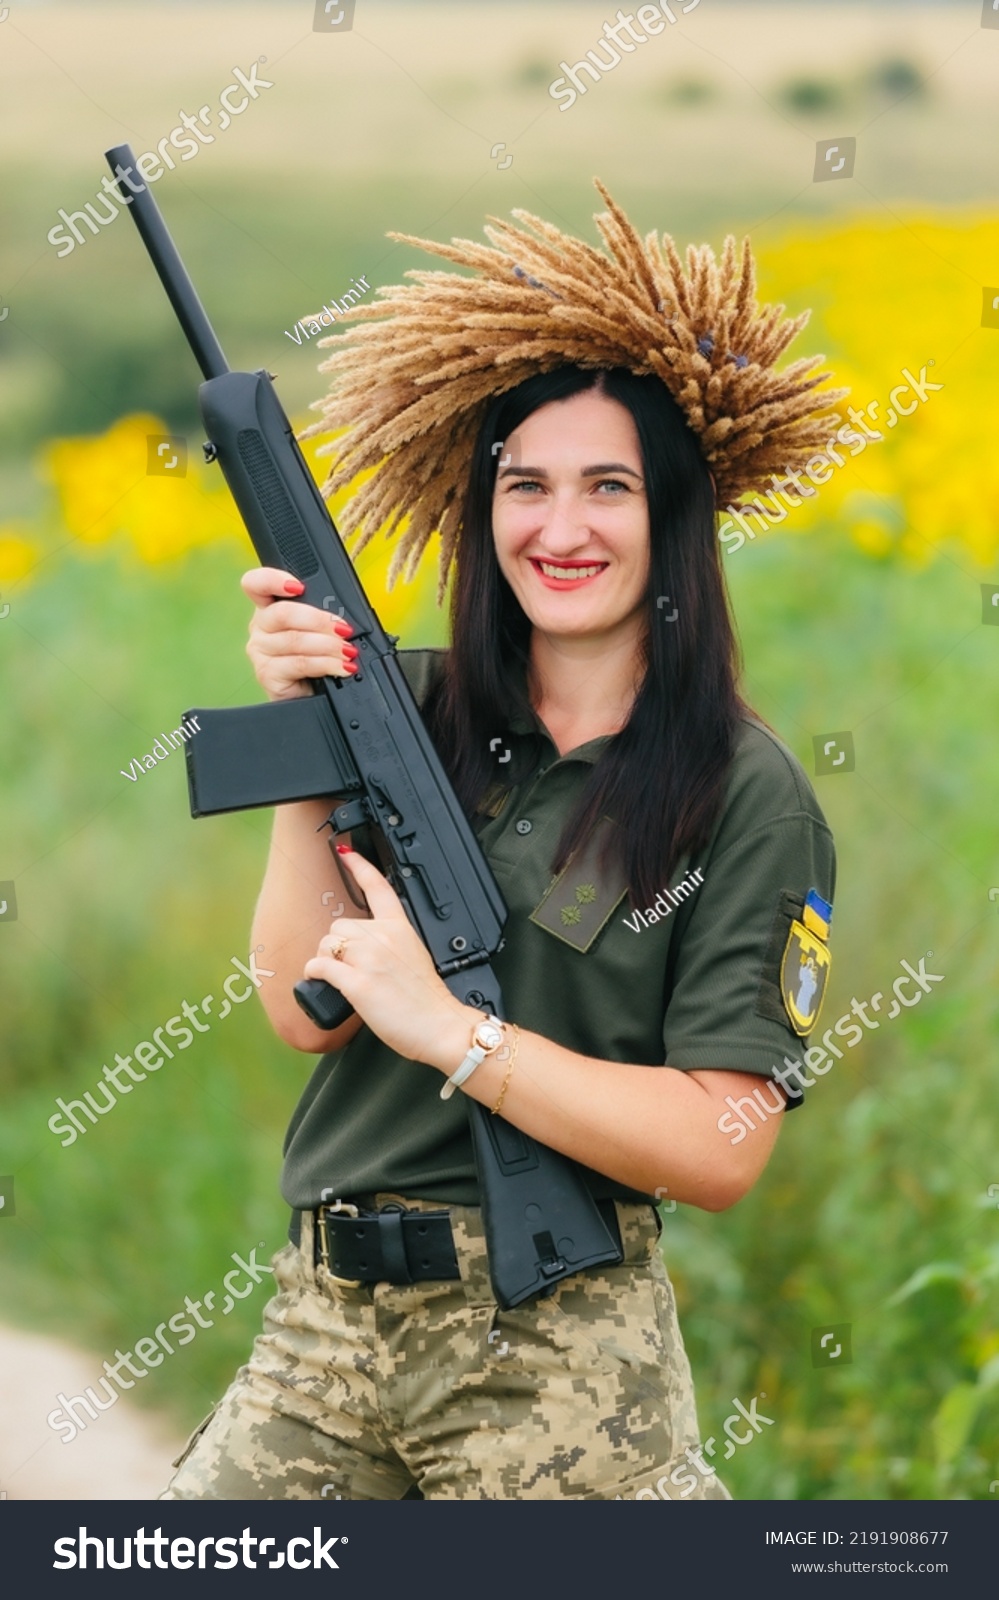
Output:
top-left (493, 389), bottom-right (648, 638)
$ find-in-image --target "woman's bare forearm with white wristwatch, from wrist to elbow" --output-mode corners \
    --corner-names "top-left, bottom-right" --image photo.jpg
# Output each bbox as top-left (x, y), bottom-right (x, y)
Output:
top-left (431, 1006), bottom-right (780, 1211)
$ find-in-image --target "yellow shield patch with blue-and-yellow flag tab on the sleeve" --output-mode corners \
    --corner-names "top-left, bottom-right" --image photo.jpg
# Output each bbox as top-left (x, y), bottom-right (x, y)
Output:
top-left (756, 890), bottom-right (833, 1038)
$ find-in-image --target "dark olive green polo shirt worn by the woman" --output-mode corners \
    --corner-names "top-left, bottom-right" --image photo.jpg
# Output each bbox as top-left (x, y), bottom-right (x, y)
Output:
top-left (282, 650), bottom-right (836, 1208)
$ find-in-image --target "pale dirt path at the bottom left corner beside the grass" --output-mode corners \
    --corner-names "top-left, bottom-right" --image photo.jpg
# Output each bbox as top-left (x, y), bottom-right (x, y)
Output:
top-left (0, 1328), bottom-right (183, 1501)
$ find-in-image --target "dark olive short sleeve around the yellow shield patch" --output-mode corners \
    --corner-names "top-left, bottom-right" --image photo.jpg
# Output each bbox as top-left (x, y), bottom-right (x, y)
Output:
top-left (663, 722), bottom-right (836, 1104)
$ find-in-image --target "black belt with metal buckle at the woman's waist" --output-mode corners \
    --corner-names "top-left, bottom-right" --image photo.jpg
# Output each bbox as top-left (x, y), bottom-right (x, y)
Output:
top-left (290, 1200), bottom-right (620, 1288)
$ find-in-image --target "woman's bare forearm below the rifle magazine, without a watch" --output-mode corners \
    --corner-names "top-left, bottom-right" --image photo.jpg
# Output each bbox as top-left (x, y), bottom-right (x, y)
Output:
top-left (250, 800), bottom-right (365, 1054)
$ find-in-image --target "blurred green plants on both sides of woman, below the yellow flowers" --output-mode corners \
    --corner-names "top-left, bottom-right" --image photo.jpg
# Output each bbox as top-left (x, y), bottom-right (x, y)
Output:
top-left (0, 518), bottom-right (999, 1501)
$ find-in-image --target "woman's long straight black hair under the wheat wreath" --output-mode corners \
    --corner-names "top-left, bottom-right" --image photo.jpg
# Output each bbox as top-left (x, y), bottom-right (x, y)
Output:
top-left (426, 366), bottom-right (746, 906)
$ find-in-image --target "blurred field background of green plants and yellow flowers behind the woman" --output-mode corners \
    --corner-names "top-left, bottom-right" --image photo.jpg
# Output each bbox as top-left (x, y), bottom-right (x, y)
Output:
top-left (0, 0), bottom-right (999, 1501)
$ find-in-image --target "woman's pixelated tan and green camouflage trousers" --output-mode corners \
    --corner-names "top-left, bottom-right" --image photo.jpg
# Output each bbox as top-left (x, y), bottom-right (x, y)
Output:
top-left (160, 1194), bottom-right (730, 1501)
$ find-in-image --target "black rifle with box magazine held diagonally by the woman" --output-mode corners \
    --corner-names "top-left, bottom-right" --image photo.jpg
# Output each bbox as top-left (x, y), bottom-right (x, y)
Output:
top-left (106, 144), bottom-right (621, 1307)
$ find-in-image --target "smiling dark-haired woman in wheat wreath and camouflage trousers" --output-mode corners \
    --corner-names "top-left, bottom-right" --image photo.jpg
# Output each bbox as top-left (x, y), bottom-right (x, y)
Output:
top-left (167, 184), bottom-right (837, 1499)
